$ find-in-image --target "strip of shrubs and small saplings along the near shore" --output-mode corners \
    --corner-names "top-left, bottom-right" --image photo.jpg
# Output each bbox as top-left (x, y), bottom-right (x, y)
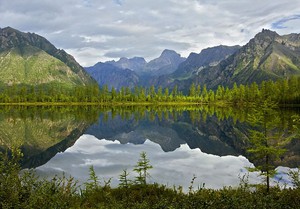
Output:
top-left (0, 149), bottom-right (300, 209)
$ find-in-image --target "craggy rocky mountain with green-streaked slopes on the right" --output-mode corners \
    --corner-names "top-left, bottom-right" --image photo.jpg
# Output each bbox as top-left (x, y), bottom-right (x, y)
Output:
top-left (186, 30), bottom-right (300, 88)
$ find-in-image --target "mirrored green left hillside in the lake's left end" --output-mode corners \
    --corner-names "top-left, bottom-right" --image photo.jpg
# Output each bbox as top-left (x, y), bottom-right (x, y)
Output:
top-left (0, 106), bottom-right (95, 168)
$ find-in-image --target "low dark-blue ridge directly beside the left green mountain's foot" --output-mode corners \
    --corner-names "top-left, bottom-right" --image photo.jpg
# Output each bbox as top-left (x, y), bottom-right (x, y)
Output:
top-left (85, 62), bottom-right (139, 90)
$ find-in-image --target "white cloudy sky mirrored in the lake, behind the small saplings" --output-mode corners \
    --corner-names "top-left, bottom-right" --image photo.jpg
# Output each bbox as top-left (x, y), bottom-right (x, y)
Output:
top-left (37, 135), bottom-right (287, 191)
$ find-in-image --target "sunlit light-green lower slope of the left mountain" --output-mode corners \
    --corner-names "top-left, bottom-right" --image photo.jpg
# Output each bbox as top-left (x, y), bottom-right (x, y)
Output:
top-left (0, 46), bottom-right (88, 87)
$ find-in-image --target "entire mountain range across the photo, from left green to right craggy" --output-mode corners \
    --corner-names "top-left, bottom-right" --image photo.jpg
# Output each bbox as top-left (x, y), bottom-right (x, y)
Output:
top-left (0, 27), bottom-right (300, 92)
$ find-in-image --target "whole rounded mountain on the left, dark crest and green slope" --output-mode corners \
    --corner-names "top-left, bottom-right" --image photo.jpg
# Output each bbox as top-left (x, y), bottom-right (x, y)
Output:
top-left (0, 27), bottom-right (95, 87)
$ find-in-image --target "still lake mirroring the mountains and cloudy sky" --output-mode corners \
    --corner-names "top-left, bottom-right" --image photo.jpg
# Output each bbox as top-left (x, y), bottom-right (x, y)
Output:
top-left (0, 106), bottom-right (300, 191)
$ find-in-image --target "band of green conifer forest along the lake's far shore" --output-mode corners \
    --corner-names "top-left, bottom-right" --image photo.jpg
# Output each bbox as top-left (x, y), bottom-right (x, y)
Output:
top-left (0, 77), bottom-right (300, 106)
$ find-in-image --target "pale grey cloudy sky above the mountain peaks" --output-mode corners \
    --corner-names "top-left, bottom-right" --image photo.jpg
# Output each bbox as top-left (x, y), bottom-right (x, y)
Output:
top-left (0, 0), bottom-right (300, 67)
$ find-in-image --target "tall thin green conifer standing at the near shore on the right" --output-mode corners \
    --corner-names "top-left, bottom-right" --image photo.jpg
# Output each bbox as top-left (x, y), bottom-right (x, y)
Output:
top-left (247, 100), bottom-right (289, 192)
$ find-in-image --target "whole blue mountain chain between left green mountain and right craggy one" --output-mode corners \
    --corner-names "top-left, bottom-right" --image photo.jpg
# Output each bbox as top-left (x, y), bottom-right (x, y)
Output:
top-left (85, 46), bottom-right (240, 89)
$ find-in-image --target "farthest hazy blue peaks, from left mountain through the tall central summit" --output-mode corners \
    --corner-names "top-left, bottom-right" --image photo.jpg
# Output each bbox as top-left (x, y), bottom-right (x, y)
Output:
top-left (85, 49), bottom-right (185, 89)
